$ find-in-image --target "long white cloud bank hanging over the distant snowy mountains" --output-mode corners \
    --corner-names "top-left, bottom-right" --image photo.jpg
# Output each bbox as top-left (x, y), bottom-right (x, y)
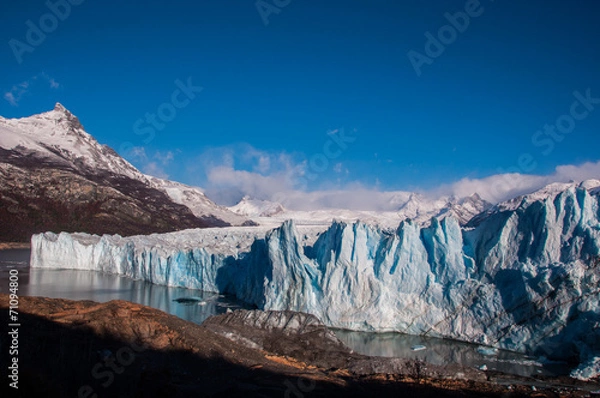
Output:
top-left (173, 144), bottom-right (600, 211)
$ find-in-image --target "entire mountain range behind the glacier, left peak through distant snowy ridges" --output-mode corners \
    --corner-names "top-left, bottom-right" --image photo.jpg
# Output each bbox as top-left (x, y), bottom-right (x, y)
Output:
top-left (0, 103), bottom-right (600, 241)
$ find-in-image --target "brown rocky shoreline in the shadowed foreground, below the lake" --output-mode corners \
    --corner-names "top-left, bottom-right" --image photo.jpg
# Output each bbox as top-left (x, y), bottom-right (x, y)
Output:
top-left (0, 294), bottom-right (600, 397)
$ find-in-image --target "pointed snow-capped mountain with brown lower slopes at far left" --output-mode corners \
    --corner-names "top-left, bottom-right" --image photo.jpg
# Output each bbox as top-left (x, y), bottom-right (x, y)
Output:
top-left (0, 103), bottom-right (249, 239)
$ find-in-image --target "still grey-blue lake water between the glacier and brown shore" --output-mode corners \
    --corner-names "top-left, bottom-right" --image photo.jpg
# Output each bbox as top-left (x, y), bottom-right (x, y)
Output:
top-left (0, 250), bottom-right (568, 376)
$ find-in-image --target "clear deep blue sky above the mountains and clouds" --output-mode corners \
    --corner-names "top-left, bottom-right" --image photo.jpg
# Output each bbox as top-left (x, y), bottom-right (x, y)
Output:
top-left (0, 0), bottom-right (600, 204)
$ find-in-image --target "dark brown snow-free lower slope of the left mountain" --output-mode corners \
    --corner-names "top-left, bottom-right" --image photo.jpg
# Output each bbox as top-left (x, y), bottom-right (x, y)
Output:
top-left (0, 159), bottom-right (223, 242)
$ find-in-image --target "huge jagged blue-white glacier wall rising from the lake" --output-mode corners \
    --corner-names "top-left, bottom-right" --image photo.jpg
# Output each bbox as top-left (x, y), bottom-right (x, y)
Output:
top-left (31, 180), bottom-right (600, 378)
